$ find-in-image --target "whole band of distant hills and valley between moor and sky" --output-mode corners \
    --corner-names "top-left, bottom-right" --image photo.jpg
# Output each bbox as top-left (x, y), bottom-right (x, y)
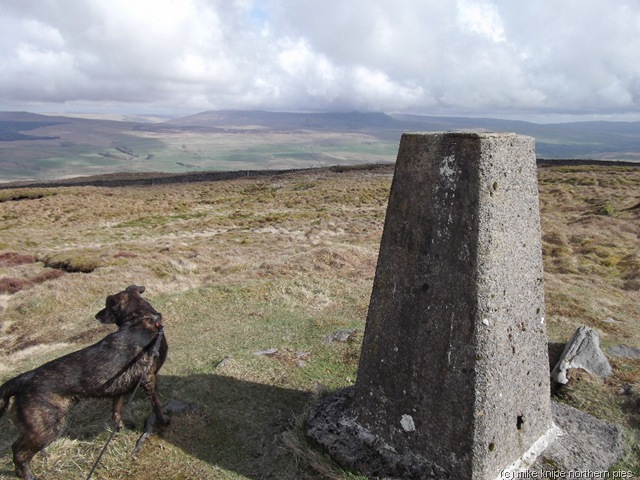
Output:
top-left (0, 110), bottom-right (640, 181)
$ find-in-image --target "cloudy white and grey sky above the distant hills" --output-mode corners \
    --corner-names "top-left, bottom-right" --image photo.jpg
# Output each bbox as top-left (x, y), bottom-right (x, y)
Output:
top-left (0, 0), bottom-right (640, 121)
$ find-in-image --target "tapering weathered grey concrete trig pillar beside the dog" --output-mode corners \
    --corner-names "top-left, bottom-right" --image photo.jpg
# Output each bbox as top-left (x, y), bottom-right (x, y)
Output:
top-left (354, 133), bottom-right (551, 479)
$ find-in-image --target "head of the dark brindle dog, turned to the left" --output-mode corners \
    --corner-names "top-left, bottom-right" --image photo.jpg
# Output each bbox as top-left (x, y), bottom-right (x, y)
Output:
top-left (96, 285), bottom-right (162, 328)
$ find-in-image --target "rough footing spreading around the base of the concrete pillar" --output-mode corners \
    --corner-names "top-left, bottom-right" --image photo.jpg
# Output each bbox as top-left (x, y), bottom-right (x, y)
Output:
top-left (307, 388), bottom-right (625, 480)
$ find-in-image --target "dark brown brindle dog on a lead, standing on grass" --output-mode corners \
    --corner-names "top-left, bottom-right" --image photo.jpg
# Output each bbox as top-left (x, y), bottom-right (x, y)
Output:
top-left (0, 285), bottom-right (169, 480)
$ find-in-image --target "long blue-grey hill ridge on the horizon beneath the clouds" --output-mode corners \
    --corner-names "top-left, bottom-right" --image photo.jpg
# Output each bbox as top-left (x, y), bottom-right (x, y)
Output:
top-left (159, 110), bottom-right (640, 161)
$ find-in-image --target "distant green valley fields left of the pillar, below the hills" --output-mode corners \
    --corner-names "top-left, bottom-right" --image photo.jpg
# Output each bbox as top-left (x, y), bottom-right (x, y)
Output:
top-left (0, 133), bottom-right (398, 181)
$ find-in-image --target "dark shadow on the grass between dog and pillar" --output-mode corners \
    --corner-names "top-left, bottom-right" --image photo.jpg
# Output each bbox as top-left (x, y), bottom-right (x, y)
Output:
top-left (156, 374), bottom-right (312, 479)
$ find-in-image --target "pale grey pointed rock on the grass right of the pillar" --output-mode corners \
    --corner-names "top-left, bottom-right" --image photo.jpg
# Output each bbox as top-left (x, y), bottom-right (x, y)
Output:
top-left (551, 325), bottom-right (612, 385)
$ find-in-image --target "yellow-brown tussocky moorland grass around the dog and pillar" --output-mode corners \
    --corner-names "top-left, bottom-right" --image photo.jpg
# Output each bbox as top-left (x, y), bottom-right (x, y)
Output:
top-left (0, 163), bottom-right (640, 480)
